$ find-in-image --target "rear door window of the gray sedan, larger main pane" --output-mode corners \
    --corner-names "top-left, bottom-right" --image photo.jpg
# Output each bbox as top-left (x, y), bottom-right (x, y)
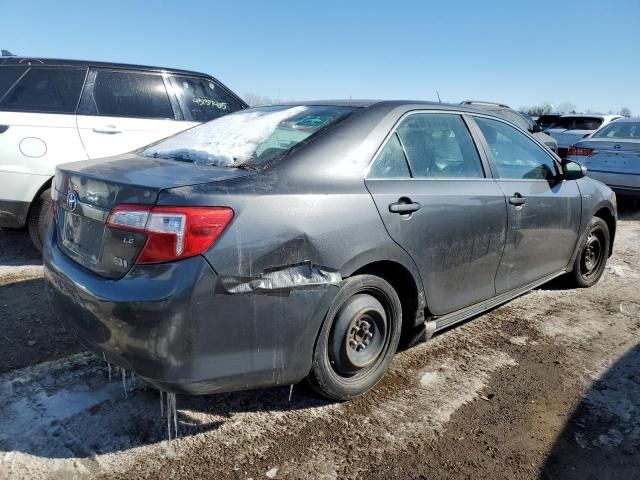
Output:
top-left (397, 113), bottom-right (484, 178)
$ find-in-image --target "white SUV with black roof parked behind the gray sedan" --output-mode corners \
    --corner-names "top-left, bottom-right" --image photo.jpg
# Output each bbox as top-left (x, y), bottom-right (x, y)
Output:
top-left (0, 57), bottom-right (247, 248)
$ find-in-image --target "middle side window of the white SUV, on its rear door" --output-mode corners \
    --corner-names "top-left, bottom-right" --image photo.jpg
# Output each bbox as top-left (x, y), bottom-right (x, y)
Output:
top-left (78, 70), bottom-right (174, 119)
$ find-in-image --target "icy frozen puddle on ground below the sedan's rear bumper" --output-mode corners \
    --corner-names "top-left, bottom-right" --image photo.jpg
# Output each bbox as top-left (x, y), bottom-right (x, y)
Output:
top-left (0, 352), bottom-right (338, 479)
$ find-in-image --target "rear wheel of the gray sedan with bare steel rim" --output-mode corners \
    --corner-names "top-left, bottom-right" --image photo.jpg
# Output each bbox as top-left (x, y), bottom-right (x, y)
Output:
top-left (307, 275), bottom-right (402, 401)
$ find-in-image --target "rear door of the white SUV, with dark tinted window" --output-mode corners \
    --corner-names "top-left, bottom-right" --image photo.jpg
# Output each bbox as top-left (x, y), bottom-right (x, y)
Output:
top-left (77, 69), bottom-right (190, 158)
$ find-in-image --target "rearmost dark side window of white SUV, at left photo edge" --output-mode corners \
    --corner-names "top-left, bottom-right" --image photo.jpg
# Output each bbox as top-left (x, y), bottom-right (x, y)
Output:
top-left (0, 67), bottom-right (86, 113)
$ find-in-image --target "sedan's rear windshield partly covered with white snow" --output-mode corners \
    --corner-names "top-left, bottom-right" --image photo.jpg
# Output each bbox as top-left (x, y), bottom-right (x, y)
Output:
top-left (141, 105), bottom-right (353, 167)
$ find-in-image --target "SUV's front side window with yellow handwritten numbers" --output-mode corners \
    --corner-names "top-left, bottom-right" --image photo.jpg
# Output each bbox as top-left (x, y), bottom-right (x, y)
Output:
top-left (170, 76), bottom-right (242, 122)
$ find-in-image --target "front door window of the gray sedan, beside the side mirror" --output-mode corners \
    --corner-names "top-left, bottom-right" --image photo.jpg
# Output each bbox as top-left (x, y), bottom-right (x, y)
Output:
top-left (475, 117), bottom-right (558, 180)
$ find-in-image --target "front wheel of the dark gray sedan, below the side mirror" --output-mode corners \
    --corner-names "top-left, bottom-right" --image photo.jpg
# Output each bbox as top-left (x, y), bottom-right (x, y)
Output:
top-left (569, 217), bottom-right (610, 288)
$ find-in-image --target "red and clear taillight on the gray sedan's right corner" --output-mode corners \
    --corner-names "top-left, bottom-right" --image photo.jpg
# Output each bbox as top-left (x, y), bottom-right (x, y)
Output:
top-left (107, 204), bottom-right (233, 263)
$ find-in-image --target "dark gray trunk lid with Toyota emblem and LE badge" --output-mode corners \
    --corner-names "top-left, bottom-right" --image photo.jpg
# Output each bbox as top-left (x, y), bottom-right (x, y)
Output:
top-left (53, 154), bottom-right (253, 279)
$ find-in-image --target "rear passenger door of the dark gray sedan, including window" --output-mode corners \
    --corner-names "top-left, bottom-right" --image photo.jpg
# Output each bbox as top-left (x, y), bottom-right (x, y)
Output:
top-left (366, 112), bottom-right (507, 315)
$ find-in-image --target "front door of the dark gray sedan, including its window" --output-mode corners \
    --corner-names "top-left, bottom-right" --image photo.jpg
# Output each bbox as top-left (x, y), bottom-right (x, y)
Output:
top-left (474, 116), bottom-right (582, 294)
